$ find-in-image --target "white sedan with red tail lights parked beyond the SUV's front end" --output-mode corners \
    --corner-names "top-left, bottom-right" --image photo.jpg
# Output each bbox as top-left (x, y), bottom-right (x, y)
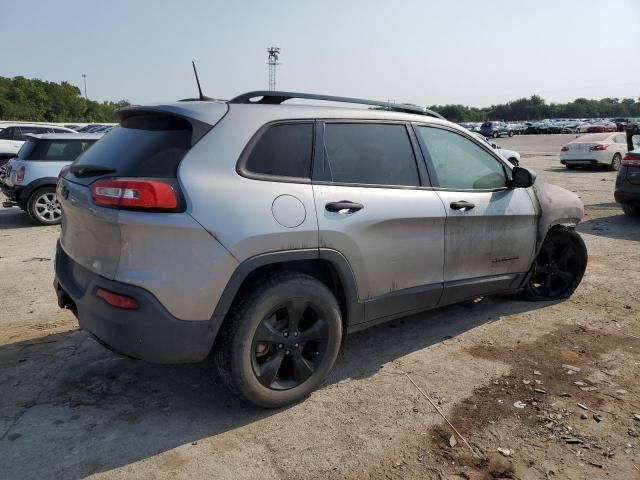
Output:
top-left (560, 132), bottom-right (627, 170)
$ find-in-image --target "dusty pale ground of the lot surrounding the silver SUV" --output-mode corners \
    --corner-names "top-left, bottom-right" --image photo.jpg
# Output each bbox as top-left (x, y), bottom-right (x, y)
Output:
top-left (0, 135), bottom-right (640, 479)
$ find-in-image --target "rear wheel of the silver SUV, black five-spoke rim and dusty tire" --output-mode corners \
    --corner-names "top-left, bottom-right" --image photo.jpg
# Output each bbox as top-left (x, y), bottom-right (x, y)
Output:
top-left (214, 272), bottom-right (342, 408)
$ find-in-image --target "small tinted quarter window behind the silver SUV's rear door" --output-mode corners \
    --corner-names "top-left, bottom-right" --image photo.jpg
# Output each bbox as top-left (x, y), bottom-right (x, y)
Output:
top-left (244, 123), bottom-right (313, 178)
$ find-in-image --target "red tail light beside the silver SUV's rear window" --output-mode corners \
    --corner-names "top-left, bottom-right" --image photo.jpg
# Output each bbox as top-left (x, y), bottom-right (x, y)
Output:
top-left (91, 178), bottom-right (178, 210)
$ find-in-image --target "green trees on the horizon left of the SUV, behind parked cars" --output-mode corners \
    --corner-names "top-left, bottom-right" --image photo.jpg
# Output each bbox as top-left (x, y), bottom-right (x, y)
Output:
top-left (0, 77), bottom-right (129, 123)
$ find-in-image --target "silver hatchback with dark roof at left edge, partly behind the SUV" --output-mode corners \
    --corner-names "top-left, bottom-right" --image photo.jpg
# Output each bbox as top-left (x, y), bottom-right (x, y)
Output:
top-left (0, 133), bottom-right (102, 225)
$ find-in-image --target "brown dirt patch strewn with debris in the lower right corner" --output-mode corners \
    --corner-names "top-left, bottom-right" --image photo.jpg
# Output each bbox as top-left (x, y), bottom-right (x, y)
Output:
top-left (360, 325), bottom-right (640, 480)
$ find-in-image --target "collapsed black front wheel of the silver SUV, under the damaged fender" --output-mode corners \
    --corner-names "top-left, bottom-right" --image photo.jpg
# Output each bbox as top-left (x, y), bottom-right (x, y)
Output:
top-left (520, 227), bottom-right (588, 301)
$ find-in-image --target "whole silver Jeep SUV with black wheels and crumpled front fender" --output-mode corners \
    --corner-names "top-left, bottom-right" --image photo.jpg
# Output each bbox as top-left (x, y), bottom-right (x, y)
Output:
top-left (55, 91), bottom-right (587, 407)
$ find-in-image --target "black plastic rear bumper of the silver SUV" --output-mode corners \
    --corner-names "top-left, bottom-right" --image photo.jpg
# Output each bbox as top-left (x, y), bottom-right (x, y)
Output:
top-left (54, 242), bottom-right (221, 363)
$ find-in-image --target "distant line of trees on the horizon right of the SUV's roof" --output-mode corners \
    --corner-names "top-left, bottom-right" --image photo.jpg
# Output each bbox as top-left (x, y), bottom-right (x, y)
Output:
top-left (429, 95), bottom-right (640, 122)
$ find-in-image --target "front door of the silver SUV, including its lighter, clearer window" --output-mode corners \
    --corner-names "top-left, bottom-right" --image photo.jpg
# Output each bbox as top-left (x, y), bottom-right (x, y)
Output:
top-left (416, 125), bottom-right (536, 303)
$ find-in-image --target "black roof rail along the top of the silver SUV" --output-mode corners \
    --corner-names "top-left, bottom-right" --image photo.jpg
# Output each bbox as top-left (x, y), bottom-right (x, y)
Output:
top-left (229, 90), bottom-right (446, 120)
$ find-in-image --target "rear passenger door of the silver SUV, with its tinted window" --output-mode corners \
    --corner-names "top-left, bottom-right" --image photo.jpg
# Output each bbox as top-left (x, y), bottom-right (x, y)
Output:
top-left (313, 121), bottom-right (445, 321)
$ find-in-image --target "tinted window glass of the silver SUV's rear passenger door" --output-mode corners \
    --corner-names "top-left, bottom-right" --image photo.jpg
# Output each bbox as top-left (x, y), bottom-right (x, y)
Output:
top-left (323, 123), bottom-right (420, 186)
